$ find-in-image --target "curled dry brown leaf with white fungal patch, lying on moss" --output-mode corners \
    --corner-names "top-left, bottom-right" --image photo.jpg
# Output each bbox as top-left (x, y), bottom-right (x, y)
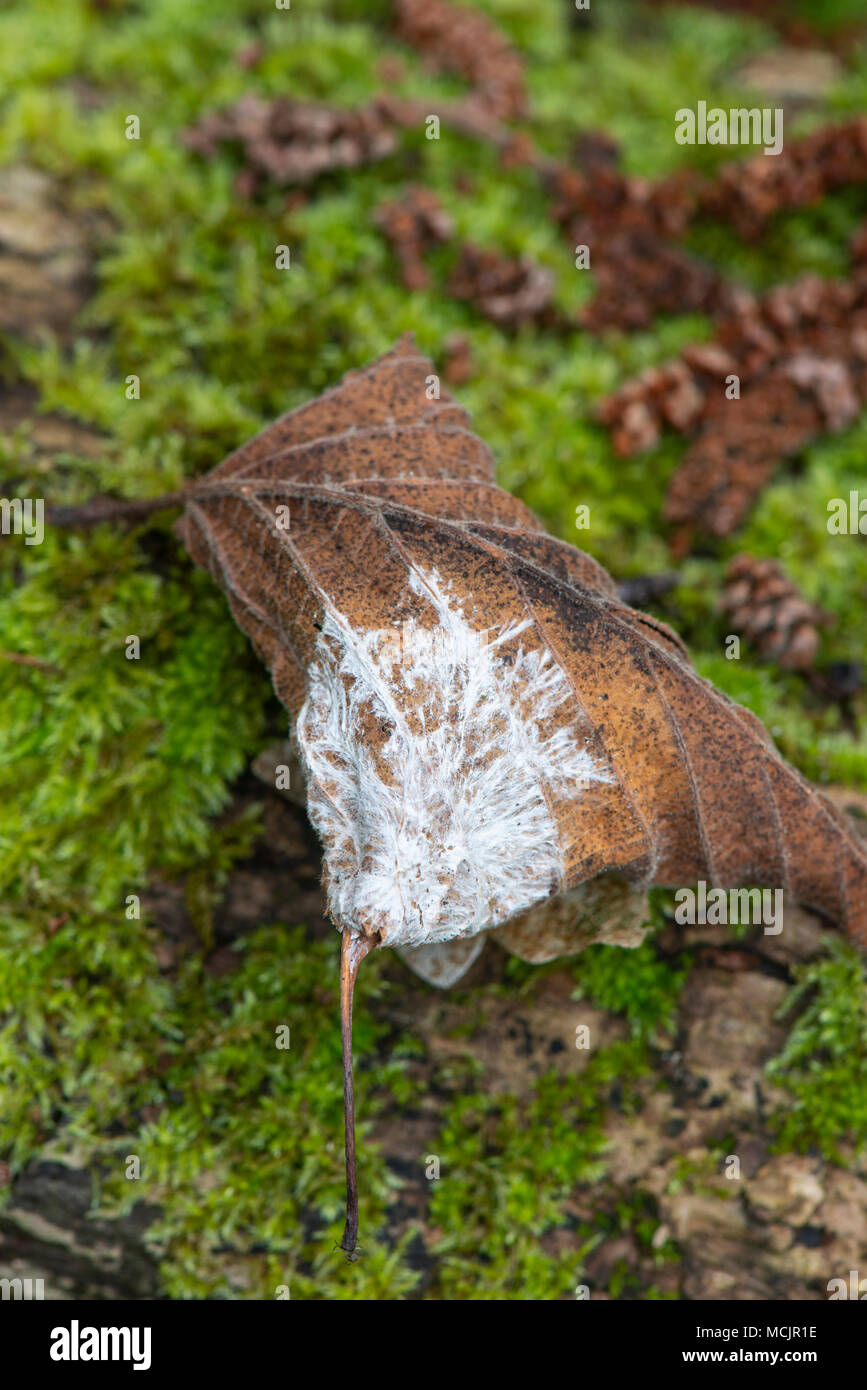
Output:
top-left (179, 338), bottom-right (867, 948)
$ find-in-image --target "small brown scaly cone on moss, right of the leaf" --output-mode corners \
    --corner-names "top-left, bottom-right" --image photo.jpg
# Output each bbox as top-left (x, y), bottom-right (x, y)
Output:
top-left (718, 555), bottom-right (831, 671)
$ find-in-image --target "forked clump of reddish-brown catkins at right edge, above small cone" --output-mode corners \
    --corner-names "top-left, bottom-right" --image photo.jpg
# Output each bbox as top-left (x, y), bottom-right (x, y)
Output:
top-left (596, 268), bottom-right (867, 544)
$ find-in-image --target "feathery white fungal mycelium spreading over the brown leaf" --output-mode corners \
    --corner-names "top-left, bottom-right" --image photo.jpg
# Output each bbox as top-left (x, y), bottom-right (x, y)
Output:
top-left (296, 570), bottom-right (613, 947)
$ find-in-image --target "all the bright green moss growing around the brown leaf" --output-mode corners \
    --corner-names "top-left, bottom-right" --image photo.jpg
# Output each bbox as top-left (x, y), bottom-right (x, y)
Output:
top-left (0, 0), bottom-right (867, 1298)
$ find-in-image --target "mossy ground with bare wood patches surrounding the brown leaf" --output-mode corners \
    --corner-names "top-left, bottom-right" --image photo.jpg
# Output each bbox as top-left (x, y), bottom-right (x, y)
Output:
top-left (0, 0), bottom-right (867, 1300)
